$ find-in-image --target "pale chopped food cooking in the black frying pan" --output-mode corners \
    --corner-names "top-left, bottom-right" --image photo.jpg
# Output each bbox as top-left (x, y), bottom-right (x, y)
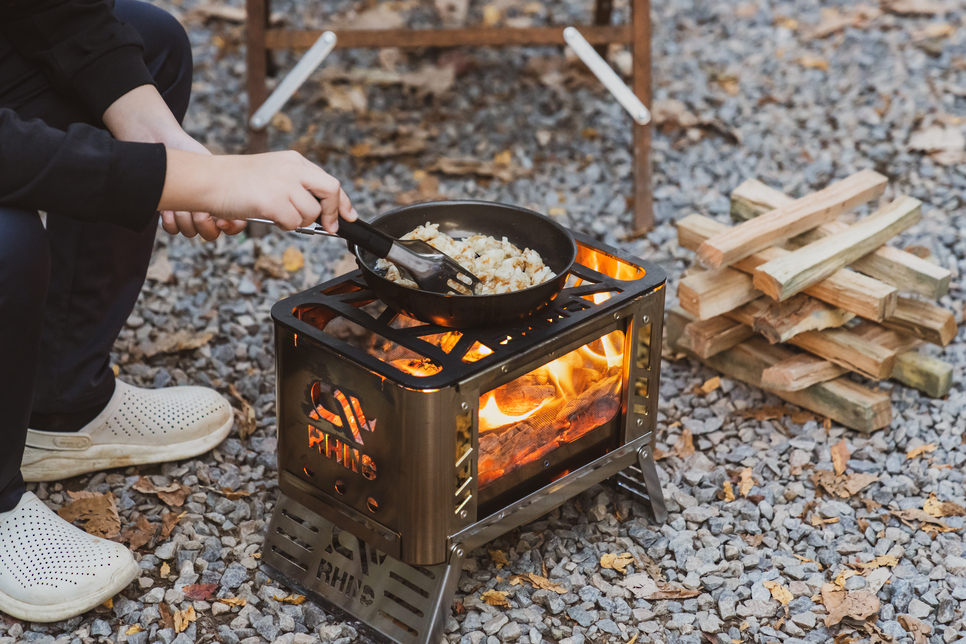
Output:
top-left (376, 222), bottom-right (554, 295)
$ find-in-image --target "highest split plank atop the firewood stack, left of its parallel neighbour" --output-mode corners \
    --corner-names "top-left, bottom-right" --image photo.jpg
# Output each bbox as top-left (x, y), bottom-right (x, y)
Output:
top-left (698, 170), bottom-right (888, 268)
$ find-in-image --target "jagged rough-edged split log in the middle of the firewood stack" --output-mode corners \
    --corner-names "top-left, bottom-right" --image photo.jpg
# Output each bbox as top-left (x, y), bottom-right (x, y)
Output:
top-left (745, 293), bottom-right (855, 344)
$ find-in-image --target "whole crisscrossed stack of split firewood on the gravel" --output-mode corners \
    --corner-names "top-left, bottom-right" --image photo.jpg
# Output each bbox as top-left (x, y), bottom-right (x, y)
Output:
top-left (668, 170), bottom-right (957, 432)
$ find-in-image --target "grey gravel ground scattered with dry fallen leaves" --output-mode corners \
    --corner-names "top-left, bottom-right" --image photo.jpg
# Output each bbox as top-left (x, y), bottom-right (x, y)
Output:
top-left (0, 0), bottom-right (966, 644)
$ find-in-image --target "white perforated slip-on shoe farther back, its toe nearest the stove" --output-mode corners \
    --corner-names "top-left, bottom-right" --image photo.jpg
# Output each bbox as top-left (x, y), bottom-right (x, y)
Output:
top-left (21, 380), bottom-right (234, 482)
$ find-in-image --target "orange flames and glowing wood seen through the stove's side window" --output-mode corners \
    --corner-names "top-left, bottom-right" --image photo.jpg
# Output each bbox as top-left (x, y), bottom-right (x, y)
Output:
top-left (479, 330), bottom-right (624, 486)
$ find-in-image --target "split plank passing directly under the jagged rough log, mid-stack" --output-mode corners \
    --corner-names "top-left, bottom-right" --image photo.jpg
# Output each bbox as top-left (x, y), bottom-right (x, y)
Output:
top-left (726, 305), bottom-right (896, 380)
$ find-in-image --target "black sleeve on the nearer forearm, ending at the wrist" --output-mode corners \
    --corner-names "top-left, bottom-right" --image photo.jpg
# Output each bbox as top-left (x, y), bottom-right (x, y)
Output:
top-left (0, 108), bottom-right (167, 230)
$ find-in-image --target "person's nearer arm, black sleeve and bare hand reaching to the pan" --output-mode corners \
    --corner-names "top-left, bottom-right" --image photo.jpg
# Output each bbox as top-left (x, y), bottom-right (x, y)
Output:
top-left (0, 108), bottom-right (356, 232)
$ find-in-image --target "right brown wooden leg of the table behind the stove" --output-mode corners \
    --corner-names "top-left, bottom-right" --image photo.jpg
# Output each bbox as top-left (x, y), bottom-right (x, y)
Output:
top-left (631, 0), bottom-right (654, 231)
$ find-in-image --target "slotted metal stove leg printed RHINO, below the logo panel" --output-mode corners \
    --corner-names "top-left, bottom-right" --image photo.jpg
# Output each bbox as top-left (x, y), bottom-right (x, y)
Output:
top-left (262, 494), bottom-right (466, 644)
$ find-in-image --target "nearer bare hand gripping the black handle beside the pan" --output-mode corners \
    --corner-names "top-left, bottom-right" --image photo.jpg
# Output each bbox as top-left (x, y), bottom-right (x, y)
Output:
top-left (158, 148), bottom-right (357, 233)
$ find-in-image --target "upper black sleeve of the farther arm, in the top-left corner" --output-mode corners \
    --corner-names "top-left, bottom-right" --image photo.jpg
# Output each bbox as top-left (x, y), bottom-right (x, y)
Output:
top-left (0, 0), bottom-right (154, 118)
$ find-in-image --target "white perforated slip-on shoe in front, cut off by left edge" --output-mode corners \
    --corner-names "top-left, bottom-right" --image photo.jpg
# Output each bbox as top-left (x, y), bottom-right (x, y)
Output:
top-left (0, 492), bottom-right (140, 622)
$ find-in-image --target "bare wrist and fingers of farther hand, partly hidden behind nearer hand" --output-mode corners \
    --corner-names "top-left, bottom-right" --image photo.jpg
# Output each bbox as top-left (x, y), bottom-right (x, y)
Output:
top-left (101, 85), bottom-right (245, 241)
